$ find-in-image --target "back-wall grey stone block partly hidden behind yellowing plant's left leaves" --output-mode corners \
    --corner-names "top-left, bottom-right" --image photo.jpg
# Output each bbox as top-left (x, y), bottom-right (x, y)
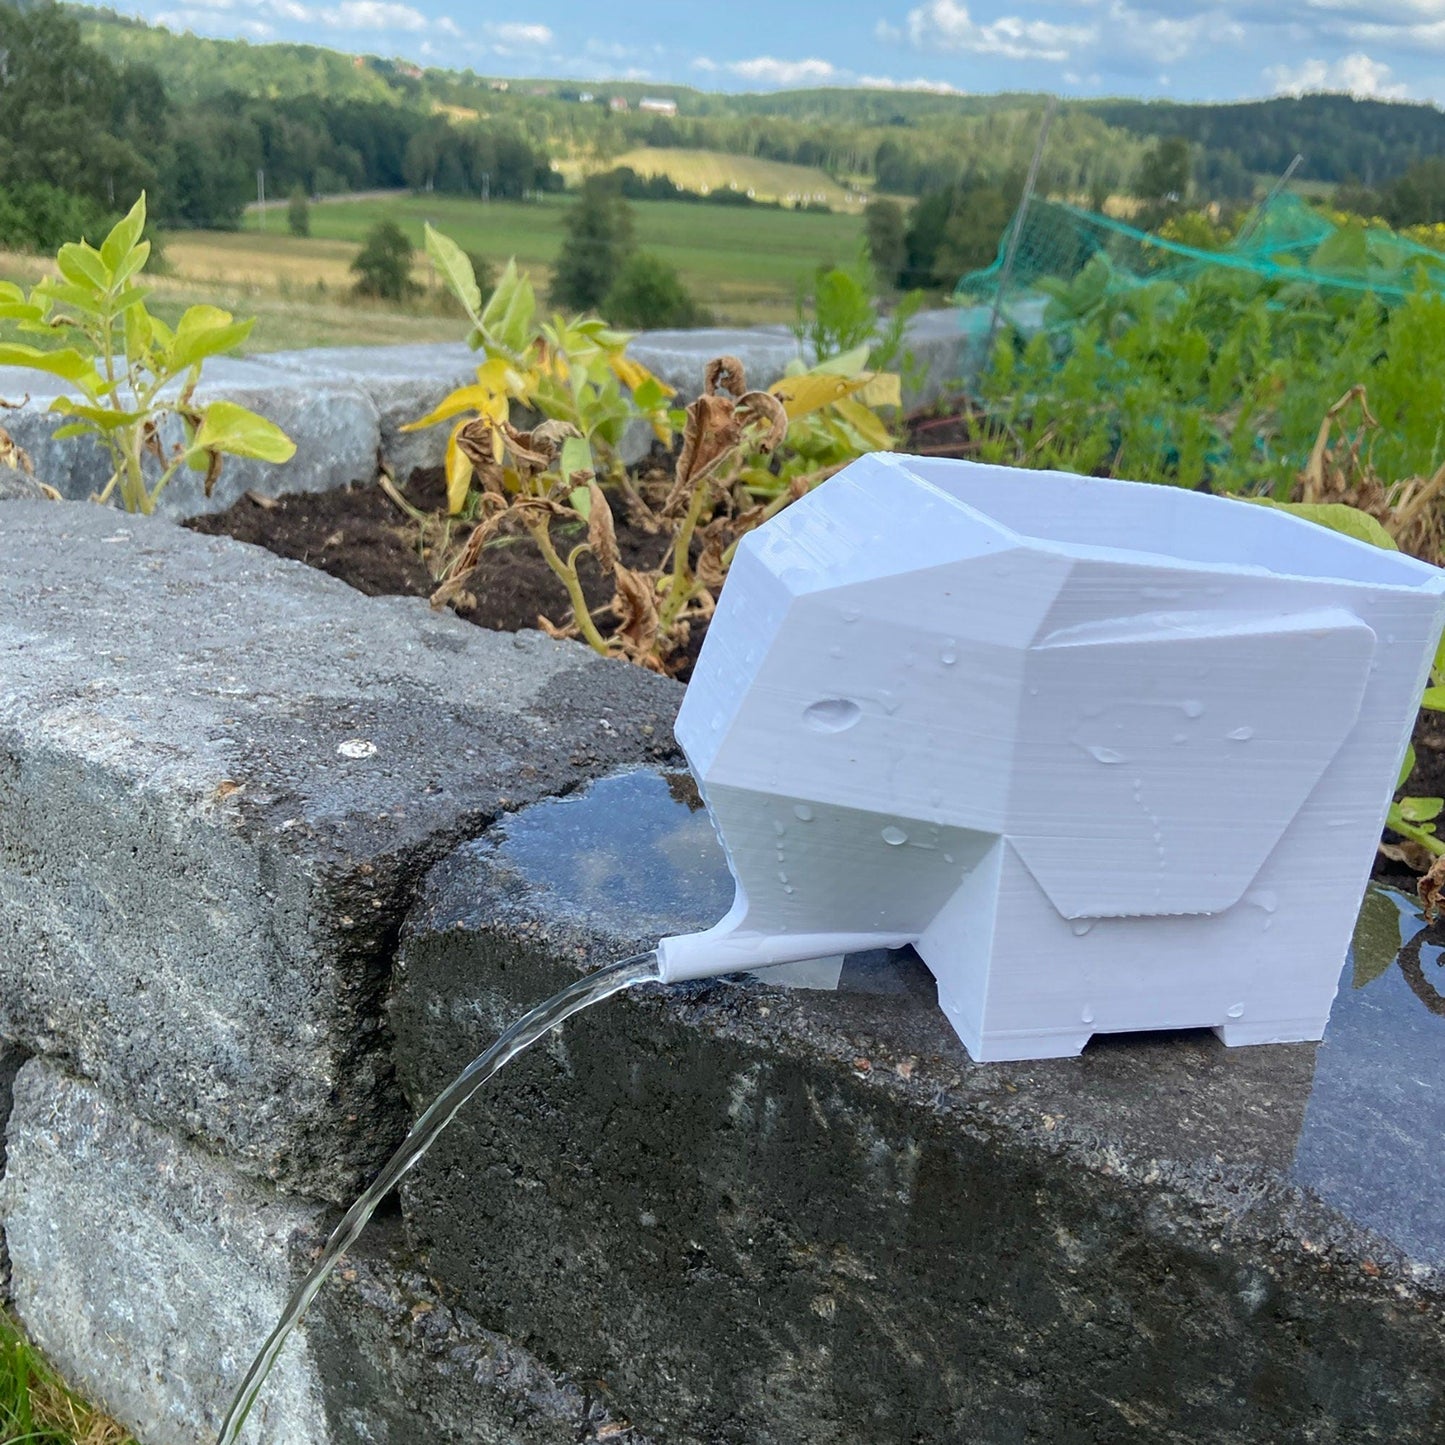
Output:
top-left (264, 341), bottom-right (484, 483)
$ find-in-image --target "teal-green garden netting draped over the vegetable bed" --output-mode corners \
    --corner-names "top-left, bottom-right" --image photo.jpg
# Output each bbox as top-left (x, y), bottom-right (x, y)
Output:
top-left (954, 195), bottom-right (1445, 322)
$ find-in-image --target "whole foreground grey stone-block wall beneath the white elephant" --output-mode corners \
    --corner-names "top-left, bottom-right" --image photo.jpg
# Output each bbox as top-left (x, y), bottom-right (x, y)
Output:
top-left (0, 375), bottom-right (1445, 1445)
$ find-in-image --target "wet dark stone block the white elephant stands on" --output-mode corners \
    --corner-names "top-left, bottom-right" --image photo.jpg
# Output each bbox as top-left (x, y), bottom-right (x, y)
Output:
top-left (392, 775), bottom-right (1445, 1445)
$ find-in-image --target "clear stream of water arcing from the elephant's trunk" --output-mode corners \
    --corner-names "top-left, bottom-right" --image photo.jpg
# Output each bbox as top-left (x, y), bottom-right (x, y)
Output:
top-left (217, 952), bottom-right (660, 1445)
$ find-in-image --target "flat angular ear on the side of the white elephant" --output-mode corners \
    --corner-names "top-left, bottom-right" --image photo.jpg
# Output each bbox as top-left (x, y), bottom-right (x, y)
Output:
top-left (1009, 608), bottom-right (1383, 919)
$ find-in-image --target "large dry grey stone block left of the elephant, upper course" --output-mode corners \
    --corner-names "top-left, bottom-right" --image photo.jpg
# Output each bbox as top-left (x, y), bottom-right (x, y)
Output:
top-left (0, 501), bottom-right (681, 1201)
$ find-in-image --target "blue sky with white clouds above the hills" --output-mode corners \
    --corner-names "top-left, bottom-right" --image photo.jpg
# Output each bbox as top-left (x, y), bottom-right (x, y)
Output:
top-left (111, 0), bottom-right (1445, 101)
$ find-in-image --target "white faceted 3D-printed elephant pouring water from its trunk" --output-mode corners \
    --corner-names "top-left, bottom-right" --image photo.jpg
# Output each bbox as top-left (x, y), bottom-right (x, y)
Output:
top-left (660, 455), bottom-right (1445, 1061)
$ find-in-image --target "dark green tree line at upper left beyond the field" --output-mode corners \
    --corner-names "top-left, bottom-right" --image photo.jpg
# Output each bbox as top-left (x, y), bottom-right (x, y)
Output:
top-left (0, 0), bottom-right (551, 250)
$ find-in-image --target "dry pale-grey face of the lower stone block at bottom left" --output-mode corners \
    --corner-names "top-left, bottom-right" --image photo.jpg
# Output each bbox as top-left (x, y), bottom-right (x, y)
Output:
top-left (0, 1059), bottom-right (329, 1445)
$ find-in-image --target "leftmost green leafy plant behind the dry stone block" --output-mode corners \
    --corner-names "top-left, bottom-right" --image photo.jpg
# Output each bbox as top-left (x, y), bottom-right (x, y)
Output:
top-left (0, 195), bottom-right (296, 513)
